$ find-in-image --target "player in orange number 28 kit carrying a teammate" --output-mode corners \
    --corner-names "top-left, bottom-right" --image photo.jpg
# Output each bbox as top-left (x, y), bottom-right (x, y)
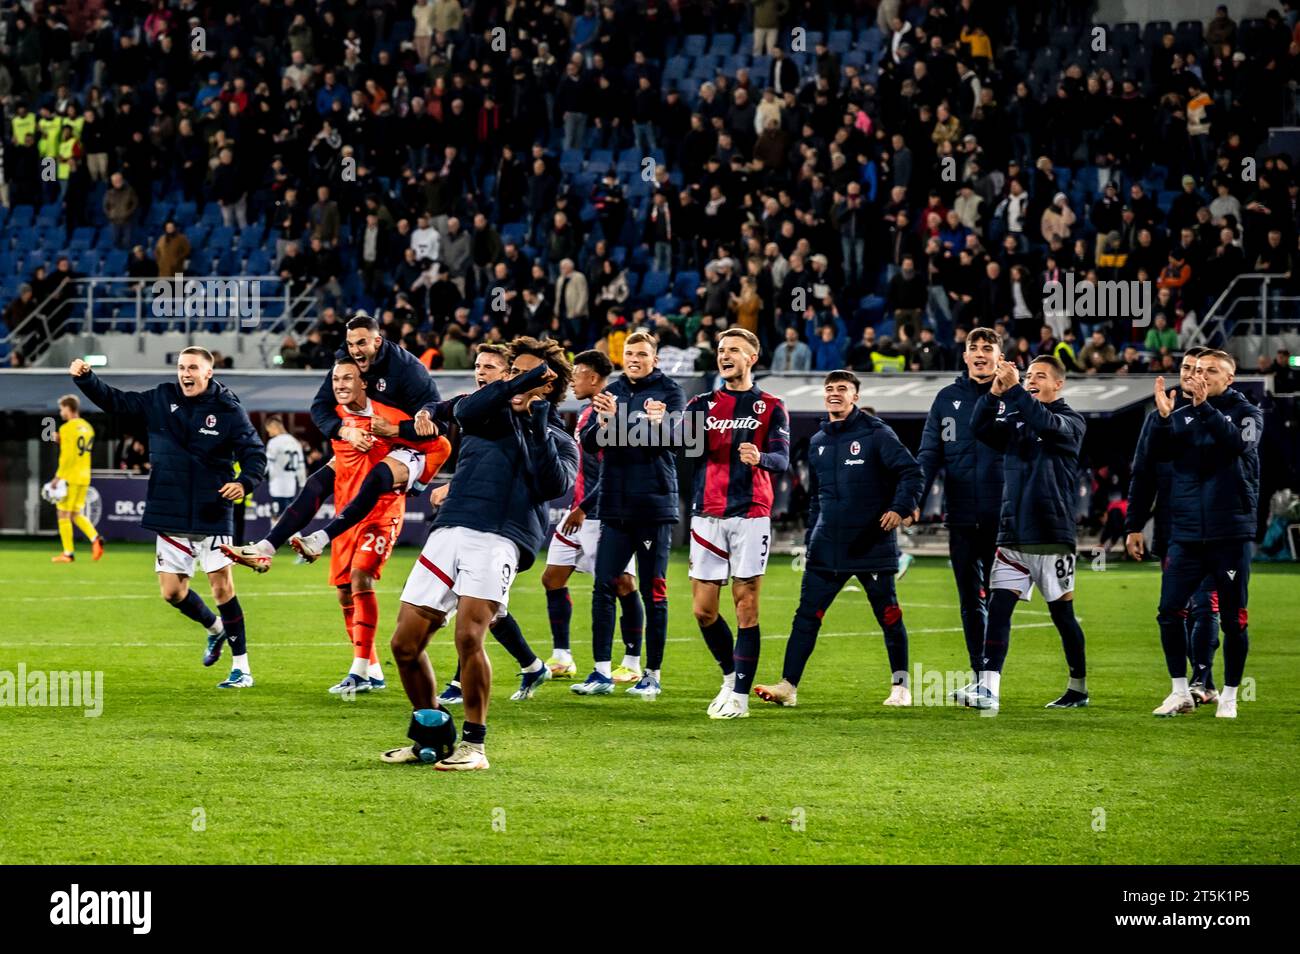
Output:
top-left (318, 357), bottom-right (451, 698)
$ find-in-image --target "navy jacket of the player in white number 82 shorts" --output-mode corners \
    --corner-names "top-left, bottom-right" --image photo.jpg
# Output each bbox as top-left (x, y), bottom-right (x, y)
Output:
top-left (971, 385), bottom-right (1087, 548)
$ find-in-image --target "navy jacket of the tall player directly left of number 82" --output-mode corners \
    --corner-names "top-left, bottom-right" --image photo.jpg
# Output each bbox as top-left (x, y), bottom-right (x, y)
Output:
top-left (917, 373), bottom-right (1002, 526)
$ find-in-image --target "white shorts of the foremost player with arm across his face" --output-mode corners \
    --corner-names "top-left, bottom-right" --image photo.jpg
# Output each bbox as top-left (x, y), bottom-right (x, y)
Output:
top-left (402, 526), bottom-right (519, 619)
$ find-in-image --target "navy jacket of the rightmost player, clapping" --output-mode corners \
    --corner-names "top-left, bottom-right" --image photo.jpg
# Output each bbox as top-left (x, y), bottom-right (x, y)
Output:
top-left (1152, 387), bottom-right (1264, 543)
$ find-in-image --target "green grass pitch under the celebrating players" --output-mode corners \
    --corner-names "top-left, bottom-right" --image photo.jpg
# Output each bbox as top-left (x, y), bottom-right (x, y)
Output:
top-left (0, 541), bottom-right (1300, 864)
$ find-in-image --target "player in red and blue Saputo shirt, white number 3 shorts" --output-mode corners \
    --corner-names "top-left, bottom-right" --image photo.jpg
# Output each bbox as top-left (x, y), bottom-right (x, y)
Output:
top-left (683, 328), bottom-right (790, 719)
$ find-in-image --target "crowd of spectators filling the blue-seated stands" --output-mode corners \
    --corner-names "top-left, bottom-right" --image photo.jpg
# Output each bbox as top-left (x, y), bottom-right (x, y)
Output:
top-left (0, 0), bottom-right (1300, 380)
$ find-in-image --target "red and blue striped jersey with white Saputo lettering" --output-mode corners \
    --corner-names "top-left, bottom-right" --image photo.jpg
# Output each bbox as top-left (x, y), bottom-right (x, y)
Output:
top-left (683, 385), bottom-right (790, 517)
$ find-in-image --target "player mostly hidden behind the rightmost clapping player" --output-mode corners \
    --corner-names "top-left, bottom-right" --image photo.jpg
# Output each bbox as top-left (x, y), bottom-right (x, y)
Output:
top-left (1125, 347), bottom-right (1219, 706)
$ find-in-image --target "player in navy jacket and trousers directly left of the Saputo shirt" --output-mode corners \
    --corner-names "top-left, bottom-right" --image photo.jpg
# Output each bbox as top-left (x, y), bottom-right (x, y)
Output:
top-left (569, 331), bottom-right (686, 701)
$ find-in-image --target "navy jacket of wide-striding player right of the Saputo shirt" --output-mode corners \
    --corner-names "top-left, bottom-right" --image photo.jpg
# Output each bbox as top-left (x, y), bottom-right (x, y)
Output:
top-left (803, 408), bottom-right (922, 573)
